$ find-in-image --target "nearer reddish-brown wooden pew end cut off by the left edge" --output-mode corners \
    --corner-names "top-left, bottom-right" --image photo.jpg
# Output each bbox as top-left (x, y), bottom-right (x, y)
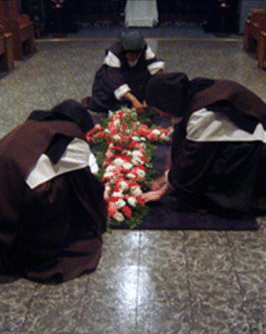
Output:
top-left (0, 26), bottom-right (14, 71)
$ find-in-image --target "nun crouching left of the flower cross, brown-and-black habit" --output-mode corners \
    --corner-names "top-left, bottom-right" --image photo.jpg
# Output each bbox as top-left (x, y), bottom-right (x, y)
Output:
top-left (0, 100), bottom-right (106, 283)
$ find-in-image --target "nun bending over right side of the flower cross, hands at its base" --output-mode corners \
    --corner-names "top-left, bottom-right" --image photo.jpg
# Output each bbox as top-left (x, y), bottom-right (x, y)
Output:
top-left (141, 73), bottom-right (266, 212)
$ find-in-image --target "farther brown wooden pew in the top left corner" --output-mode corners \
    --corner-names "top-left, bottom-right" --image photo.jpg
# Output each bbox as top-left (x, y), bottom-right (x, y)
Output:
top-left (0, 0), bottom-right (35, 60)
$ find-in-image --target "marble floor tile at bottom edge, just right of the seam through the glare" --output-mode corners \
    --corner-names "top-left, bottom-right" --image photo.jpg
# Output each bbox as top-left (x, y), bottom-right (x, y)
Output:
top-left (137, 264), bottom-right (191, 334)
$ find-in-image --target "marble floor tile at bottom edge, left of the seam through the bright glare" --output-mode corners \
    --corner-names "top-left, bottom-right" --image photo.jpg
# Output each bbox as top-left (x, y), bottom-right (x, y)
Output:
top-left (76, 265), bottom-right (139, 334)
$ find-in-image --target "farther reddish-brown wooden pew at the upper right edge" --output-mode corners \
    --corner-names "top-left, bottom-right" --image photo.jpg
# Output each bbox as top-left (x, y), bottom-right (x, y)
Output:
top-left (244, 9), bottom-right (266, 58)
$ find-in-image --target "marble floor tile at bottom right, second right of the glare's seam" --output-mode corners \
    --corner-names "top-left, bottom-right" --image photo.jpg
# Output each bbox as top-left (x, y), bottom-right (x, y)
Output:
top-left (189, 272), bottom-right (249, 334)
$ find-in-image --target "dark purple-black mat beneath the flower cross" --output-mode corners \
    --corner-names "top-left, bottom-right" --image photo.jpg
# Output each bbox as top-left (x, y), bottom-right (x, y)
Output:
top-left (111, 144), bottom-right (259, 231)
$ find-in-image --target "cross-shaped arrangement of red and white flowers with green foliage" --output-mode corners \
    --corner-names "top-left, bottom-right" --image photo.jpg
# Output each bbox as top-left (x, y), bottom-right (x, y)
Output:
top-left (86, 108), bottom-right (172, 229)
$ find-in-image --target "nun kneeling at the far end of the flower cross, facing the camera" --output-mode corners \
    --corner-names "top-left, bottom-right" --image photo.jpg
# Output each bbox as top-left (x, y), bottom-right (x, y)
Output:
top-left (82, 30), bottom-right (164, 115)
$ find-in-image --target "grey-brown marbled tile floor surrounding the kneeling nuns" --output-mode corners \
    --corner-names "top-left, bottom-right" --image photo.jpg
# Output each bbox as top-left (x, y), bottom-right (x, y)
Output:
top-left (0, 26), bottom-right (266, 334)
